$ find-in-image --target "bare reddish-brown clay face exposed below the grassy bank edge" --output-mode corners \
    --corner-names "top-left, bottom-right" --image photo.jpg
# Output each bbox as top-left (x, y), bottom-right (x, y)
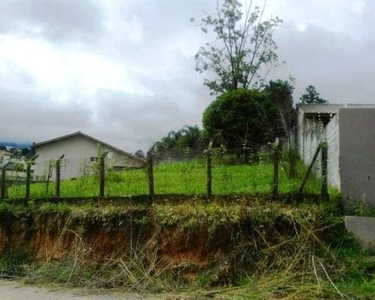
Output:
top-left (0, 213), bottom-right (231, 266)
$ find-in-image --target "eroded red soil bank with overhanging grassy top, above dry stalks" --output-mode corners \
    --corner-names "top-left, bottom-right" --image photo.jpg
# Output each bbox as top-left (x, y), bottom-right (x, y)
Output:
top-left (0, 198), bottom-right (330, 265)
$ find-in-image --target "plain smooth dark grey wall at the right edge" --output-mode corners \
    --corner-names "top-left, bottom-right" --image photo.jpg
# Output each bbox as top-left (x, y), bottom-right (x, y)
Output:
top-left (339, 109), bottom-right (375, 209)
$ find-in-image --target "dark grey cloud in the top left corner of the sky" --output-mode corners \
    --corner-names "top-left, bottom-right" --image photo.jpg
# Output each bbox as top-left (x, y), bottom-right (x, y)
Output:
top-left (0, 0), bottom-right (103, 41)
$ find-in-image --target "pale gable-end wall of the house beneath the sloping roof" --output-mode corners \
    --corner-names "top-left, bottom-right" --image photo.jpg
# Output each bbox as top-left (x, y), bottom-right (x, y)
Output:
top-left (34, 135), bottom-right (140, 179)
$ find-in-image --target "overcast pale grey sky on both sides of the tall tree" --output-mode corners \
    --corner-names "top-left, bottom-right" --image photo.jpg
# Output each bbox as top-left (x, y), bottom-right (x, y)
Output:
top-left (0, 0), bottom-right (375, 151)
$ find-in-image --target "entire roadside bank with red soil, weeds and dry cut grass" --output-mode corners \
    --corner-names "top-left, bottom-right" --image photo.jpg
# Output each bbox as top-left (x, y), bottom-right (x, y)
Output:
top-left (0, 197), bottom-right (356, 296)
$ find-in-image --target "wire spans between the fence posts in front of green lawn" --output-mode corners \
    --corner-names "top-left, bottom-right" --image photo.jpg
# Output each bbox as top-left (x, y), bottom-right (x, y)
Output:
top-left (0, 147), bottom-right (321, 199)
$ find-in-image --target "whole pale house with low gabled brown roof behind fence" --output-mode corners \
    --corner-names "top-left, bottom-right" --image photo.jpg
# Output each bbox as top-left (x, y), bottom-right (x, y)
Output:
top-left (31, 131), bottom-right (145, 179)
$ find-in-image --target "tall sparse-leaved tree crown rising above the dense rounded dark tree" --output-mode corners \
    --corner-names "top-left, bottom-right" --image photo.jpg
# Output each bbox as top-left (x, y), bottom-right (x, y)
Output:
top-left (192, 0), bottom-right (282, 94)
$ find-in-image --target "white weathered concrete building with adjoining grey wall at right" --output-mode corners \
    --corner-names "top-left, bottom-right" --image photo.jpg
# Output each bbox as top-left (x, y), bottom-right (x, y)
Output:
top-left (297, 104), bottom-right (375, 211)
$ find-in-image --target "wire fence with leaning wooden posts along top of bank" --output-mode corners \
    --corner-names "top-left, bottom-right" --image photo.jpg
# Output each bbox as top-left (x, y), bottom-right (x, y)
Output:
top-left (0, 139), bottom-right (329, 203)
